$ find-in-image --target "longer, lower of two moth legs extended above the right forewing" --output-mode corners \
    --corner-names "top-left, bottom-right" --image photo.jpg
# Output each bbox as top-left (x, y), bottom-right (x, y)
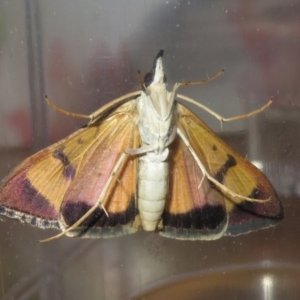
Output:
top-left (177, 94), bottom-right (273, 128)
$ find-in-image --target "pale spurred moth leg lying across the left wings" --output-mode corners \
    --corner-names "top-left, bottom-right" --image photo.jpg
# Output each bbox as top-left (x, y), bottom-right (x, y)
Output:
top-left (40, 152), bottom-right (128, 243)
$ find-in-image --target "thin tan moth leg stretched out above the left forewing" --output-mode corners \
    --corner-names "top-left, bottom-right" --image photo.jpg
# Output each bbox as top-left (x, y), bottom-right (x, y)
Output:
top-left (45, 91), bottom-right (141, 125)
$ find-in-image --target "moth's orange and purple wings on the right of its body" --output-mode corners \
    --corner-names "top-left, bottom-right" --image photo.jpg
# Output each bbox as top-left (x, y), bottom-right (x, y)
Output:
top-left (163, 104), bottom-right (283, 239)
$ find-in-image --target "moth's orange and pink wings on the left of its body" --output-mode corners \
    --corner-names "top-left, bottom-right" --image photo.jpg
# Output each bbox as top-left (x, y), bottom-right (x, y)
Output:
top-left (0, 100), bottom-right (140, 236)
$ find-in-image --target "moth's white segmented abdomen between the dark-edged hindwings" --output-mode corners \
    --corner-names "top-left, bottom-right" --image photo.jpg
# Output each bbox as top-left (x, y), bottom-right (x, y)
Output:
top-left (138, 153), bottom-right (169, 231)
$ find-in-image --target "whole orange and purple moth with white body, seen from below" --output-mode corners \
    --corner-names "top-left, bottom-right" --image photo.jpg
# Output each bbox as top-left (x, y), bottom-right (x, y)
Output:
top-left (0, 50), bottom-right (283, 240)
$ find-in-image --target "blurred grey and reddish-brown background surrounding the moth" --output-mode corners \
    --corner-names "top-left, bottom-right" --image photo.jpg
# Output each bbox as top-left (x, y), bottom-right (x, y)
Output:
top-left (0, 0), bottom-right (300, 300)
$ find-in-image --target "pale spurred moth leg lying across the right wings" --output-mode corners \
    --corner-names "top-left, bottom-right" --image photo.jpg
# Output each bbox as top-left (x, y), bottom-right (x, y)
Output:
top-left (177, 128), bottom-right (271, 203)
